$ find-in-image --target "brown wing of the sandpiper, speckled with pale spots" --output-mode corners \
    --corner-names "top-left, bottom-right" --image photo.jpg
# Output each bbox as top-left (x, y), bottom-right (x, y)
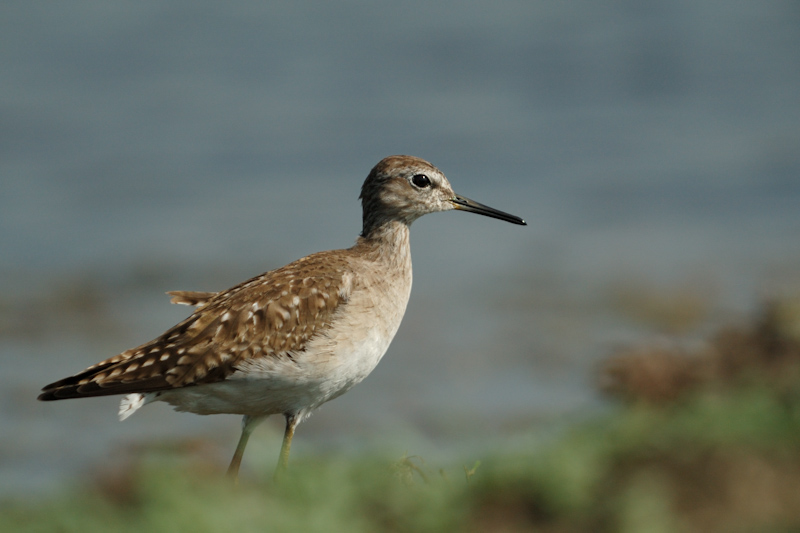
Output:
top-left (39, 250), bottom-right (353, 400)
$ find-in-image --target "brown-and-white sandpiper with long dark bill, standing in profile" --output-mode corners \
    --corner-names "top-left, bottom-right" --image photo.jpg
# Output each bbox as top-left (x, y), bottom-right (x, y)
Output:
top-left (38, 155), bottom-right (527, 480)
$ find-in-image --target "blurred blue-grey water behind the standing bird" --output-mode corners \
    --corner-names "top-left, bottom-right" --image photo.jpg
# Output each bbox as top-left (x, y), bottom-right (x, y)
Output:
top-left (0, 0), bottom-right (800, 494)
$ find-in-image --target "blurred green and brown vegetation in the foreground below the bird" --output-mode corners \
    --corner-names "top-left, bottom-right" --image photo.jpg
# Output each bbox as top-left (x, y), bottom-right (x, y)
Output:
top-left (6, 307), bottom-right (800, 533)
